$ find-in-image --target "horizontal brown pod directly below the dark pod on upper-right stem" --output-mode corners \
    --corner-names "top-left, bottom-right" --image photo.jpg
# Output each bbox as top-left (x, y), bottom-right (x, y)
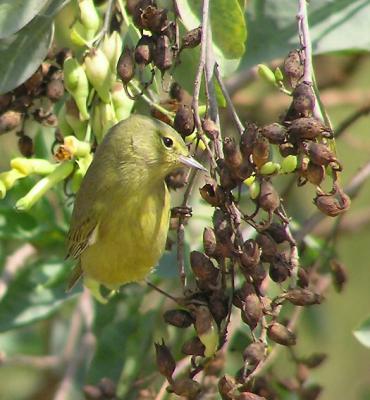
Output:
top-left (288, 117), bottom-right (333, 142)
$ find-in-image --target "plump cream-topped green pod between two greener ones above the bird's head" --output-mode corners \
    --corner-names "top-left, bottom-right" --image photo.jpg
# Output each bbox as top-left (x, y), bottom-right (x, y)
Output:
top-left (84, 48), bottom-right (112, 103)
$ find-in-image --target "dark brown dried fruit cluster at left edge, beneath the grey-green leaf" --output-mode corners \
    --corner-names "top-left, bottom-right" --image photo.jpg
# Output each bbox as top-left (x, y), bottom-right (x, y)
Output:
top-left (0, 49), bottom-right (65, 157)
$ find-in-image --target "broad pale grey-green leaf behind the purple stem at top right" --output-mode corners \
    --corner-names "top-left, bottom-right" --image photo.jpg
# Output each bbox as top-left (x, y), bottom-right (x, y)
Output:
top-left (241, 0), bottom-right (370, 68)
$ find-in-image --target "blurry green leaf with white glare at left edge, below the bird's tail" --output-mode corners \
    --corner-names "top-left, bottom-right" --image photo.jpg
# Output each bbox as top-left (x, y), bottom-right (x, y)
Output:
top-left (0, 260), bottom-right (71, 332)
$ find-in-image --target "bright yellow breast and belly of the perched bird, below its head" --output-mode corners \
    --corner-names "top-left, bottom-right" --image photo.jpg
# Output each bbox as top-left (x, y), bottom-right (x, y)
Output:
top-left (81, 184), bottom-right (170, 289)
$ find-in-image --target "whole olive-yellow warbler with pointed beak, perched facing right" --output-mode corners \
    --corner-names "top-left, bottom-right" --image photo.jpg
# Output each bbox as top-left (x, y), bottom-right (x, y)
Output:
top-left (67, 115), bottom-right (204, 302)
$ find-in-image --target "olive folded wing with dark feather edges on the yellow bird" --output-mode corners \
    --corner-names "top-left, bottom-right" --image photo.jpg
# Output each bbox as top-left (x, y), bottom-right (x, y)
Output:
top-left (66, 215), bottom-right (99, 259)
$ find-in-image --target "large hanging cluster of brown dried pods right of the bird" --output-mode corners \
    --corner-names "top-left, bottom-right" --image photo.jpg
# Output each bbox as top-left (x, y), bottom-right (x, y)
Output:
top-left (152, 47), bottom-right (349, 400)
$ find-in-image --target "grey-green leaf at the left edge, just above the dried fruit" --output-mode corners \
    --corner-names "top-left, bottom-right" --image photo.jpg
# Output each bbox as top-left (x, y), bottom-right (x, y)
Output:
top-left (0, 0), bottom-right (65, 94)
